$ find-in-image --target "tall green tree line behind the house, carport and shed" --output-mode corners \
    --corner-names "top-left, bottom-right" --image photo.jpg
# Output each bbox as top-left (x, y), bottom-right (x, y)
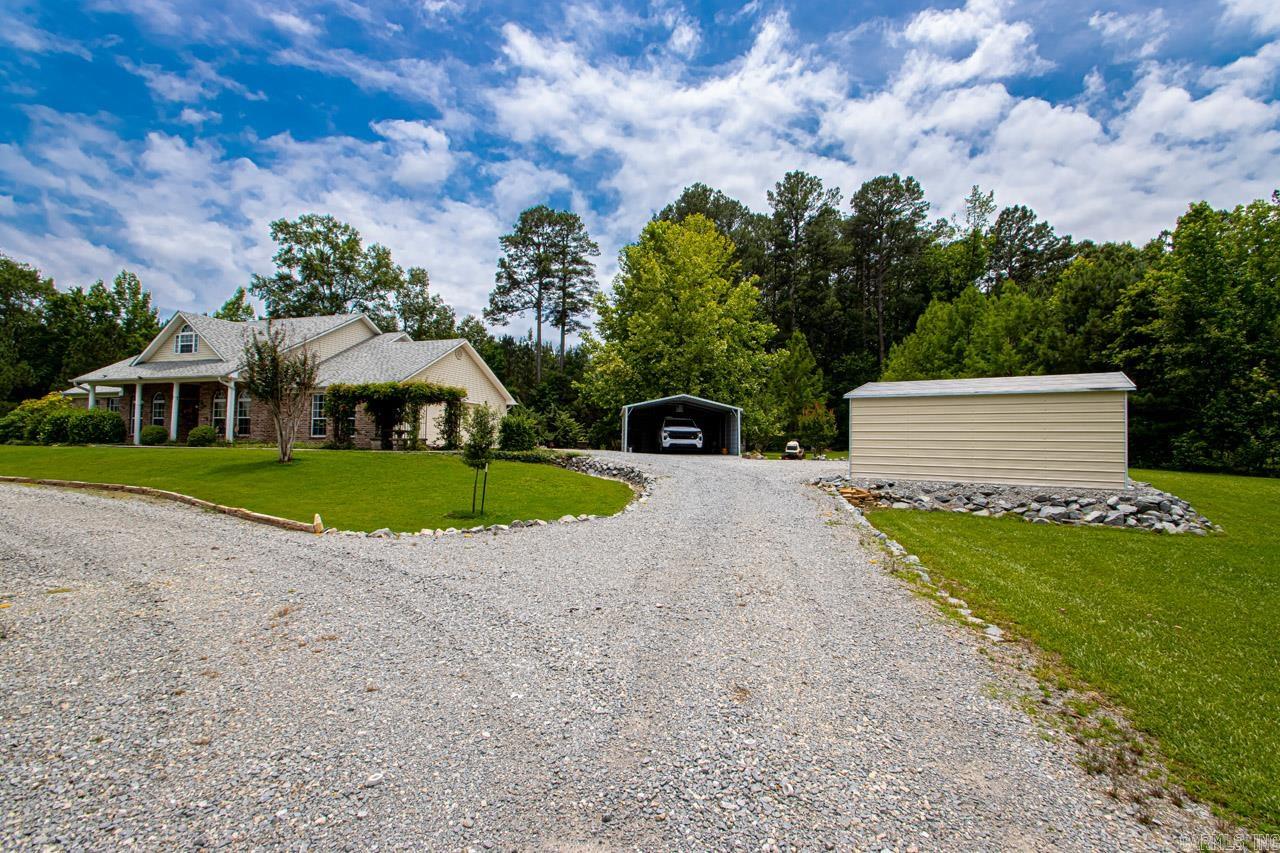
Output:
top-left (0, 178), bottom-right (1280, 473)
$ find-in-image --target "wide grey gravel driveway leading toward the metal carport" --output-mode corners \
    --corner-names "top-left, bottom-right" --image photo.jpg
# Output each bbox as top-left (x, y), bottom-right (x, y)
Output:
top-left (0, 457), bottom-right (1203, 850)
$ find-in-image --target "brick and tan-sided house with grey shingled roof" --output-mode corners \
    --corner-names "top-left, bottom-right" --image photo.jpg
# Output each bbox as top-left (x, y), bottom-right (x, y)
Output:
top-left (67, 311), bottom-right (516, 447)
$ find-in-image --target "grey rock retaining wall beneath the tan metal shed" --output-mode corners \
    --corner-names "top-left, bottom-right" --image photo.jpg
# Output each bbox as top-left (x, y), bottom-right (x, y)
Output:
top-left (813, 476), bottom-right (1217, 535)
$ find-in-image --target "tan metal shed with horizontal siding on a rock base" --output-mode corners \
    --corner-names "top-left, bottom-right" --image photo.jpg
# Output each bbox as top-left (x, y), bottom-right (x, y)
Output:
top-left (845, 373), bottom-right (1135, 489)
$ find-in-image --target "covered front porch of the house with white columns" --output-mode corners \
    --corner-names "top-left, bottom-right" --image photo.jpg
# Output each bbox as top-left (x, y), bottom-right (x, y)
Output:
top-left (86, 379), bottom-right (255, 444)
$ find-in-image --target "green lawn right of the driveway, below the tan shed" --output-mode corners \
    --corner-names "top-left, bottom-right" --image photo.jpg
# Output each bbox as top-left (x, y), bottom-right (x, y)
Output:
top-left (872, 471), bottom-right (1280, 833)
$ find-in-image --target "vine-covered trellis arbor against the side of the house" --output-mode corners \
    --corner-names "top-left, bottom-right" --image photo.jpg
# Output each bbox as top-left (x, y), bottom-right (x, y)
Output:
top-left (324, 382), bottom-right (466, 450)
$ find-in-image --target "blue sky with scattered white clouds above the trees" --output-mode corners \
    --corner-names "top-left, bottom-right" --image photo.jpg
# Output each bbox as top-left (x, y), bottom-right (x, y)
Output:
top-left (0, 0), bottom-right (1280, 325)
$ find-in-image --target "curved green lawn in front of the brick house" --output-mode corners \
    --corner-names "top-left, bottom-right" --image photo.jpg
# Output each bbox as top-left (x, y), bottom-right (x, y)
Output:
top-left (0, 446), bottom-right (631, 532)
